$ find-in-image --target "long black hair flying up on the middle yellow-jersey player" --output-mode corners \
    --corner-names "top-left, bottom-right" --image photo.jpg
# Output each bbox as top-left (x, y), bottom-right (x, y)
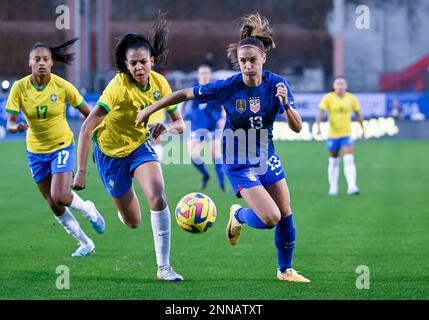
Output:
top-left (115, 12), bottom-right (168, 73)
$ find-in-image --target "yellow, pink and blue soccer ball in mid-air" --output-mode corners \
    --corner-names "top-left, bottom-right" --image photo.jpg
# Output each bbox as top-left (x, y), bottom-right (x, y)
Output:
top-left (176, 192), bottom-right (216, 233)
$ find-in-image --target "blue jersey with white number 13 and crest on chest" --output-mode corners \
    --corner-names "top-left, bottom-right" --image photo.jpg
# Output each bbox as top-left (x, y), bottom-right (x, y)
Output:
top-left (193, 71), bottom-right (294, 168)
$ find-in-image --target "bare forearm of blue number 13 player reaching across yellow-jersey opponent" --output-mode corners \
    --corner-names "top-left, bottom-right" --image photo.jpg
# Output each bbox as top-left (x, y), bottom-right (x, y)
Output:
top-left (136, 88), bottom-right (195, 127)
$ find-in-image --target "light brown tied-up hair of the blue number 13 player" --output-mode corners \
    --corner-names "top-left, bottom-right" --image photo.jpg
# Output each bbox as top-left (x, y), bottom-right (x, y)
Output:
top-left (227, 13), bottom-right (276, 68)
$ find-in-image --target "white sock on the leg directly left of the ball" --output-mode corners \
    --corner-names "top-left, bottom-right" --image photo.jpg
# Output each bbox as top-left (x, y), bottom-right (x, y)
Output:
top-left (150, 206), bottom-right (171, 268)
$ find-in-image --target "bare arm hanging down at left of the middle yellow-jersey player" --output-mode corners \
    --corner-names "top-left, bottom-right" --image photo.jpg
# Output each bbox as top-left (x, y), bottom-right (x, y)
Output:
top-left (73, 105), bottom-right (107, 190)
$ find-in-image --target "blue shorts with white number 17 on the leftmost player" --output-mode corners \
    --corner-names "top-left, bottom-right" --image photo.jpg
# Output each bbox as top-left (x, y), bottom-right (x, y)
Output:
top-left (27, 143), bottom-right (75, 183)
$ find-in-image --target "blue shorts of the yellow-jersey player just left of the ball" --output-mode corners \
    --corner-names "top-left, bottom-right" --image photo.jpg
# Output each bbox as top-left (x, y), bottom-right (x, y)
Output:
top-left (94, 139), bottom-right (159, 198)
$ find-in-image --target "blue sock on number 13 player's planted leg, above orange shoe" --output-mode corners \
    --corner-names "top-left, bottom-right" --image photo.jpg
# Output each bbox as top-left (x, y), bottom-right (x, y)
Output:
top-left (274, 215), bottom-right (295, 272)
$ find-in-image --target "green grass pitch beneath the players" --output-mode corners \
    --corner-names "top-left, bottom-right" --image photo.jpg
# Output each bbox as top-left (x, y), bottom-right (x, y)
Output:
top-left (0, 141), bottom-right (429, 299)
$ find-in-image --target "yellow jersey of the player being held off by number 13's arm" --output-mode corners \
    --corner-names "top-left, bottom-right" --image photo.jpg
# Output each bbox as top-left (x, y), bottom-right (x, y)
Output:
top-left (93, 71), bottom-right (177, 158)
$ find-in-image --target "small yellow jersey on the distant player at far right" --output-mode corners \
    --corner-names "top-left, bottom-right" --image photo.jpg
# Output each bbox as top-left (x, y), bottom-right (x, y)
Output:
top-left (319, 92), bottom-right (360, 138)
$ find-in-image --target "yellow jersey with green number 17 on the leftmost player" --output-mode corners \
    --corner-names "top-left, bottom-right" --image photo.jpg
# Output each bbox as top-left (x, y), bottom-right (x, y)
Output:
top-left (6, 74), bottom-right (84, 154)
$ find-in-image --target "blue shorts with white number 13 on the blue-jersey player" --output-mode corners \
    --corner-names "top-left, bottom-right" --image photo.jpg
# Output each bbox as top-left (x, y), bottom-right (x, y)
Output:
top-left (223, 153), bottom-right (286, 198)
